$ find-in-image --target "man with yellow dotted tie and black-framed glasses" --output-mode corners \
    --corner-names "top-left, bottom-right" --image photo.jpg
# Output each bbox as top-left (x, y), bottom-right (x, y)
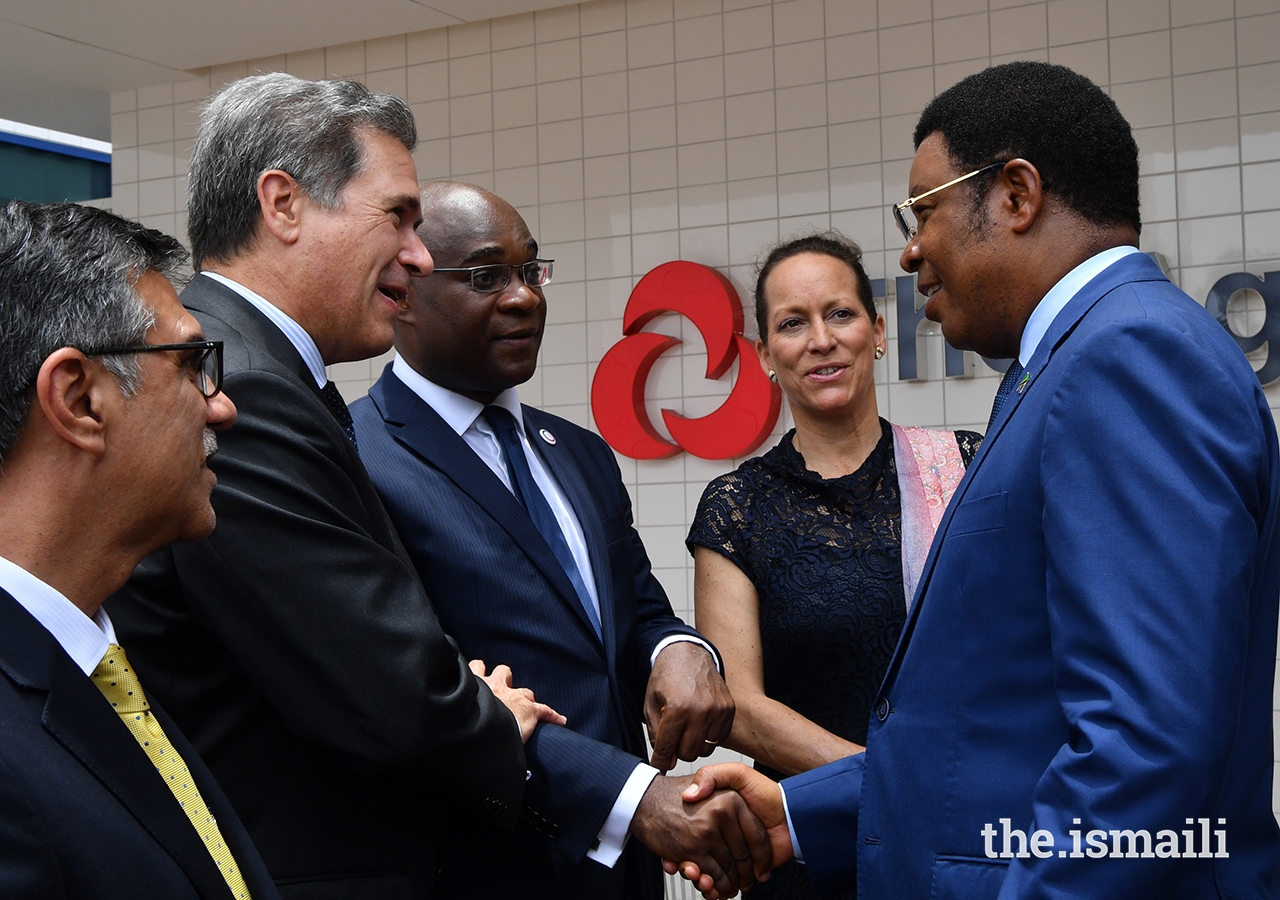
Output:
top-left (0, 201), bottom-right (276, 900)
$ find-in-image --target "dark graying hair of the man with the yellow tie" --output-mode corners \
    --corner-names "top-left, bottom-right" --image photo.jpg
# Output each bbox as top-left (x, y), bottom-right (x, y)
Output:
top-left (0, 200), bottom-right (187, 462)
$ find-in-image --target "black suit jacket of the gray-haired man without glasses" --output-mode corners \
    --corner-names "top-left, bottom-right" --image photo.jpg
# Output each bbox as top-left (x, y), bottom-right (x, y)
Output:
top-left (108, 277), bottom-right (525, 899)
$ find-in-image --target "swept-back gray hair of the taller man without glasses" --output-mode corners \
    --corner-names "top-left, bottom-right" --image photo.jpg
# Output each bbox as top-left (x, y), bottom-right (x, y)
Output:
top-left (187, 72), bottom-right (417, 271)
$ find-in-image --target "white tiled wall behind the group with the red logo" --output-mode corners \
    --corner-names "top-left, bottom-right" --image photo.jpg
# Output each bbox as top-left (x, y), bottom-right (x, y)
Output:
top-left (111, 0), bottom-right (1280, 844)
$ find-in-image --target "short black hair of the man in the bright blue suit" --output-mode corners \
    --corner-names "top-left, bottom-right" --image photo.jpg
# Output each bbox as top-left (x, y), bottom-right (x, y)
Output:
top-left (915, 60), bottom-right (1142, 230)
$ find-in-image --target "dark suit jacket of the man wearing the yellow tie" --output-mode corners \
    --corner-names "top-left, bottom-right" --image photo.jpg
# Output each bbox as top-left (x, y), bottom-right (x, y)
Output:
top-left (0, 590), bottom-right (276, 900)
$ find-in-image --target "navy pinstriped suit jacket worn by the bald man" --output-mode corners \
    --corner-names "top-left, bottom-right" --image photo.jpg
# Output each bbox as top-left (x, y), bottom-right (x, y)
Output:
top-left (351, 366), bottom-right (696, 899)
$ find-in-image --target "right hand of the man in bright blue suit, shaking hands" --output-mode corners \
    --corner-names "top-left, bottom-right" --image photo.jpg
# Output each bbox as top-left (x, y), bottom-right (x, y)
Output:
top-left (665, 763), bottom-right (792, 900)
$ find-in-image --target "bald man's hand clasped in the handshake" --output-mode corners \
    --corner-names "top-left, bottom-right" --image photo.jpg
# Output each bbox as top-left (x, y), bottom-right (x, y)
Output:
top-left (631, 775), bottom-right (768, 899)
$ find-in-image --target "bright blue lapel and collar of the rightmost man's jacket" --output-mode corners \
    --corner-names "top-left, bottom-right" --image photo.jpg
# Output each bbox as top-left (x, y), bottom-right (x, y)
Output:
top-left (886, 253), bottom-right (1167, 681)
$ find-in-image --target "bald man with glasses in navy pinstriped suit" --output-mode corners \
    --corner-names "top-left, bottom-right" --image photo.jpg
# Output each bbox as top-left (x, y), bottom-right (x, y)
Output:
top-left (352, 183), bottom-right (767, 900)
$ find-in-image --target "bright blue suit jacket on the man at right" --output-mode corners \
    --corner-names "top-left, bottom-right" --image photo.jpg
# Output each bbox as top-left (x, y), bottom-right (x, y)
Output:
top-left (785, 255), bottom-right (1280, 900)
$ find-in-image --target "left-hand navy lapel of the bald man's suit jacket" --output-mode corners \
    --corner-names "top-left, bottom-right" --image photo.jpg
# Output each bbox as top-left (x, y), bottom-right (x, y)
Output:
top-left (369, 370), bottom-right (595, 638)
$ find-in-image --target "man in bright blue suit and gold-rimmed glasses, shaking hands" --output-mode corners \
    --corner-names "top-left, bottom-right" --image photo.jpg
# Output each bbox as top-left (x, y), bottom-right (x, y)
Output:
top-left (686, 63), bottom-right (1280, 900)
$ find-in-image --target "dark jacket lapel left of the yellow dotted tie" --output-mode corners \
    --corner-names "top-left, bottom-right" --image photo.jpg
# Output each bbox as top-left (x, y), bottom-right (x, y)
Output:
top-left (0, 591), bottom-right (227, 897)
